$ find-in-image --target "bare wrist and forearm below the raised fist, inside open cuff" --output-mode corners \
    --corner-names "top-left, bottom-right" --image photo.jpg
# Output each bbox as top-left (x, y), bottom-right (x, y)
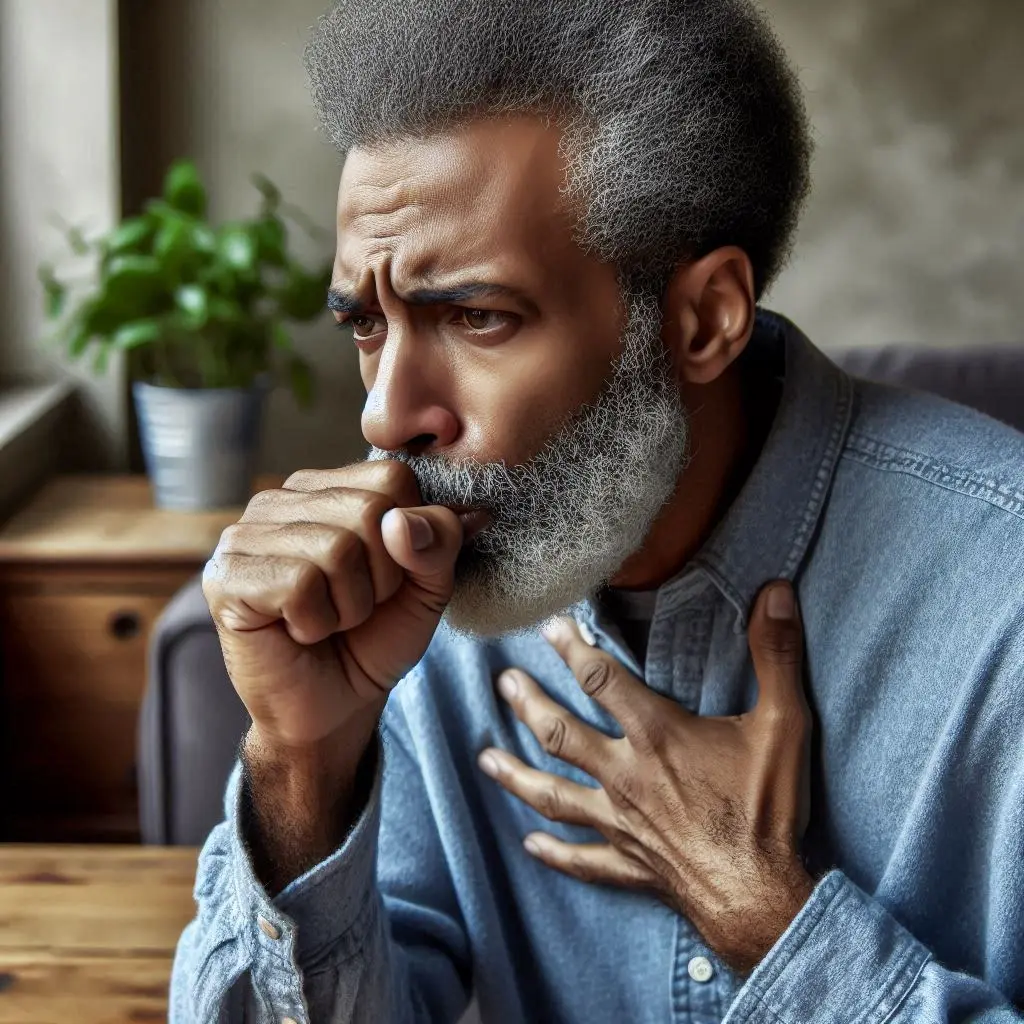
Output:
top-left (240, 712), bottom-right (378, 898)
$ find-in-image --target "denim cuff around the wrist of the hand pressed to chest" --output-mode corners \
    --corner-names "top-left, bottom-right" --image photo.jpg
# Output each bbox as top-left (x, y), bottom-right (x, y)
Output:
top-left (723, 870), bottom-right (931, 1024)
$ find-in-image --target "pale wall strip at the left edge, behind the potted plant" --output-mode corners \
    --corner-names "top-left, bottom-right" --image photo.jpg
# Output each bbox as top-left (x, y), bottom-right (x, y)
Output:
top-left (0, 0), bottom-right (125, 468)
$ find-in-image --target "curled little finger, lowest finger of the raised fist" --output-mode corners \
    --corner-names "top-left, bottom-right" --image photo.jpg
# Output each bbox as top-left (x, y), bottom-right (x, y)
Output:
top-left (203, 554), bottom-right (338, 645)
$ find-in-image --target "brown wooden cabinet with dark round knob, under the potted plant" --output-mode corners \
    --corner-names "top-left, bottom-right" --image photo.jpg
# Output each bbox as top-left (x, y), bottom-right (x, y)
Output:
top-left (0, 477), bottom-right (264, 842)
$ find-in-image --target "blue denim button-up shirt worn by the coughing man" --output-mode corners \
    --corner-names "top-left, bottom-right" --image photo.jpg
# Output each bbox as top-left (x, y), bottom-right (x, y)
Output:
top-left (171, 313), bottom-right (1024, 1024)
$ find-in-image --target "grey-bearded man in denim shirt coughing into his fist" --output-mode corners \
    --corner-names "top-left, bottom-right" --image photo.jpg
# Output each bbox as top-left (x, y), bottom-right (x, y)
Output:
top-left (172, 0), bottom-right (1024, 1024)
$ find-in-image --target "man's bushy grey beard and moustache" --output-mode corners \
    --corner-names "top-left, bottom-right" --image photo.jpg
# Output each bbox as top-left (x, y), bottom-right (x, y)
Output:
top-left (368, 294), bottom-right (688, 637)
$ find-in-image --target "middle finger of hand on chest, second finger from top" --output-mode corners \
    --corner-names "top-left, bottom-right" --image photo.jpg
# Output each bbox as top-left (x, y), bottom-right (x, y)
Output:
top-left (498, 669), bottom-right (618, 778)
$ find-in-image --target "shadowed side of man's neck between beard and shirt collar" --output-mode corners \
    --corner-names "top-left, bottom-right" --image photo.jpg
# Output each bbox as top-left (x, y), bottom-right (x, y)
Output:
top-left (611, 365), bottom-right (774, 590)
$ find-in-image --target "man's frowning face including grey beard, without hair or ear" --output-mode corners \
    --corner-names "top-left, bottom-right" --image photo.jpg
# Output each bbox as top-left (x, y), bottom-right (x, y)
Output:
top-left (332, 118), bottom-right (685, 634)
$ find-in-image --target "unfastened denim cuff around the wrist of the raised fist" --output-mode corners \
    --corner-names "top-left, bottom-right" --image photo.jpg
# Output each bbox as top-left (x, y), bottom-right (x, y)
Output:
top-left (224, 737), bottom-right (384, 972)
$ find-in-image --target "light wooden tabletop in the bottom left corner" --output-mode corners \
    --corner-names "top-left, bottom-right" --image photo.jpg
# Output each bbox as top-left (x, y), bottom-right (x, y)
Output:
top-left (0, 846), bottom-right (198, 1024)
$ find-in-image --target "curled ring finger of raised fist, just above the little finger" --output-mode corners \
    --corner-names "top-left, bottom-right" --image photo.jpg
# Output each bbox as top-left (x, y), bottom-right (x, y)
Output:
top-left (214, 522), bottom-right (375, 631)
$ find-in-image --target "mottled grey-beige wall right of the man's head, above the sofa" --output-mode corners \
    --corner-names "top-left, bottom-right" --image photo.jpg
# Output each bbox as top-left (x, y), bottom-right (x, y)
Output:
top-left (765, 0), bottom-right (1024, 346)
